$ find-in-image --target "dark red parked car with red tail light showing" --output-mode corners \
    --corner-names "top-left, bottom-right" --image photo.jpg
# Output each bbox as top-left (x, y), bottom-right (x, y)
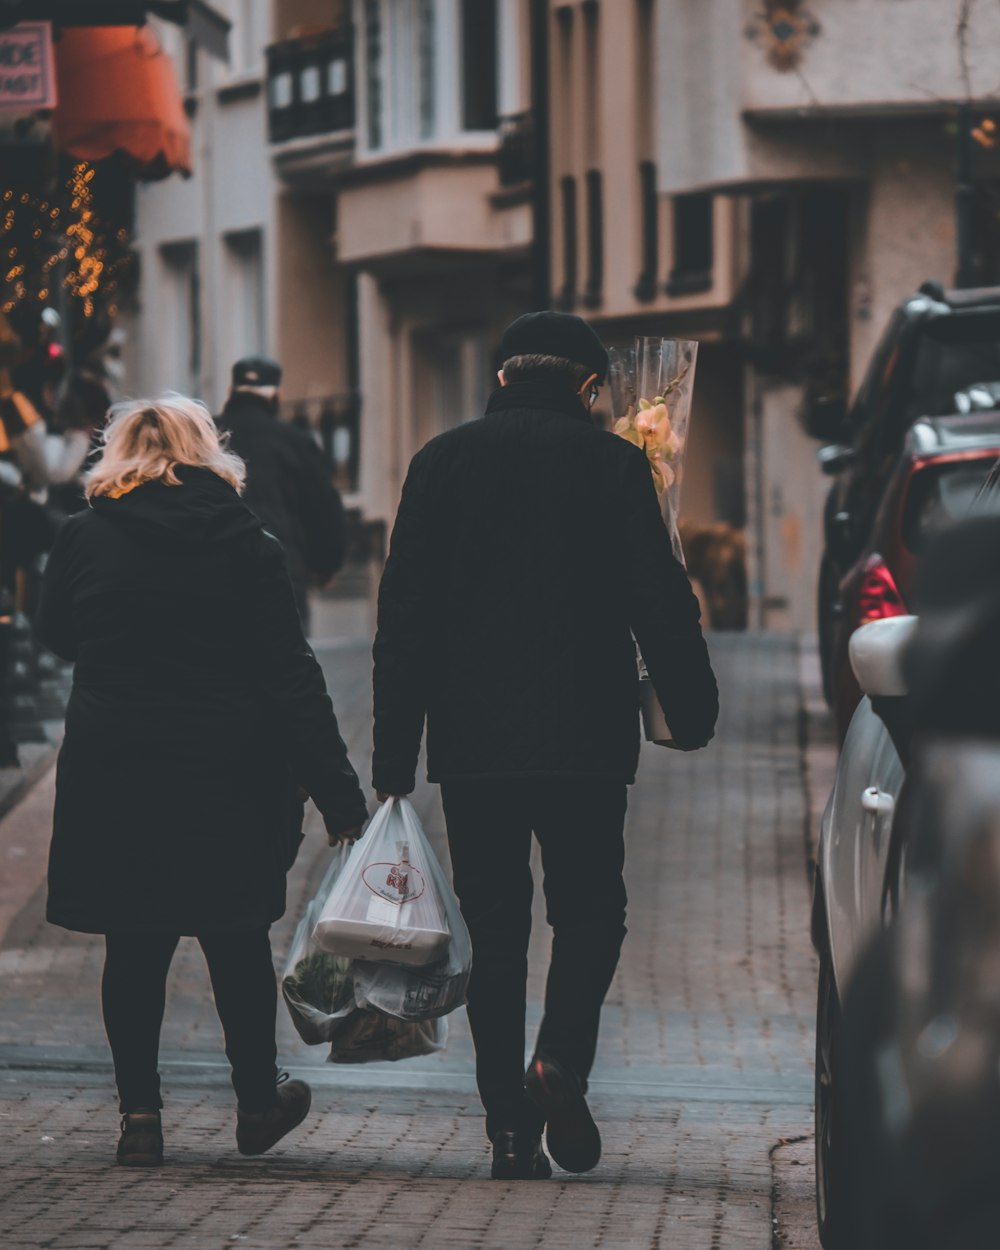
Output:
top-left (829, 415), bottom-right (1000, 741)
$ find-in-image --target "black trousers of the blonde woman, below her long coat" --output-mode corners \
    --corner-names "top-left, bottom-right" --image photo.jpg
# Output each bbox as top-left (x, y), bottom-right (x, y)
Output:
top-left (101, 928), bottom-right (278, 1111)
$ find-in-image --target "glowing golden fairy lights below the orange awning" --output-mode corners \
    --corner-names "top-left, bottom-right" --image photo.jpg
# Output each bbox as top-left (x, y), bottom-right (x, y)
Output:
top-left (0, 161), bottom-right (128, 318)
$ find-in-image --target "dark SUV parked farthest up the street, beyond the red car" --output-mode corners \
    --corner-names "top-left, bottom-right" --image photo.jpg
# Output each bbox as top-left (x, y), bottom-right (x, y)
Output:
top-left (806, 283), bottom-right (1000, 701)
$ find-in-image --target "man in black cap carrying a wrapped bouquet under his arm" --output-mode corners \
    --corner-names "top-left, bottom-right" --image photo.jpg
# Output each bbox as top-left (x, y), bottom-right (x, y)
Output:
top-left (373, 313), bottom-right (719, 1180)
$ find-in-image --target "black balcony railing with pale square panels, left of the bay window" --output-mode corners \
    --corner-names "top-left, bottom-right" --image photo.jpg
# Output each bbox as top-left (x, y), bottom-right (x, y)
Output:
top-left (268, 26), bottom-right (354, 144)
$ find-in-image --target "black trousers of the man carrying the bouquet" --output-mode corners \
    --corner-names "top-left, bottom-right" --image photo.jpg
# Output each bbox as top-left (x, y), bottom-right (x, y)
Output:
top-left (441, 778), bottom-right (628, 1138)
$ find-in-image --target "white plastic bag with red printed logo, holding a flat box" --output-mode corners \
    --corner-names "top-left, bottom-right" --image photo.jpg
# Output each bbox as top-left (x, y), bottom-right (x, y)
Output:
top-left (313, 799), bottom-right (455, 966)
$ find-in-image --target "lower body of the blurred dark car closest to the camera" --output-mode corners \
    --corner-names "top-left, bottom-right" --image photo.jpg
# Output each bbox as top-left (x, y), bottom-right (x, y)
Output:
top-left (834, 740), bottom-right (1000, 1250)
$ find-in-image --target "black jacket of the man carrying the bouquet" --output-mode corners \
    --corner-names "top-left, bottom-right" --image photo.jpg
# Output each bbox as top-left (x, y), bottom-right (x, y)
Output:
top-left (374, 383), bottom-right (719, 794)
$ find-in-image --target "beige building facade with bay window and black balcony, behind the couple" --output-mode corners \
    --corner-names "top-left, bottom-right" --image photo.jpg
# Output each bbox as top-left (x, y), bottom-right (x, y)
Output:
top-left (130, 0), bottom-right (531, 521)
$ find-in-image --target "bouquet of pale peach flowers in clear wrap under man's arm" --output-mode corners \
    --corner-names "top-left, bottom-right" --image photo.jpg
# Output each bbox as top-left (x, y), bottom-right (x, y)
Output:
top-left (609, 339), bottom-right (698, 746)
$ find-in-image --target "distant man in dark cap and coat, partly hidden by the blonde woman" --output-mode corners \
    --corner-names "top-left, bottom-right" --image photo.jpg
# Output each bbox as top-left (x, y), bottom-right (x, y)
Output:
top-left (219, 356), bottom-right (346, 629)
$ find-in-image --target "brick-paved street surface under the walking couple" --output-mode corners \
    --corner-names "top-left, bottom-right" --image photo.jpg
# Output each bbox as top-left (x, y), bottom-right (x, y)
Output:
top-left (0, 625), bottom-right (815, 1250)
